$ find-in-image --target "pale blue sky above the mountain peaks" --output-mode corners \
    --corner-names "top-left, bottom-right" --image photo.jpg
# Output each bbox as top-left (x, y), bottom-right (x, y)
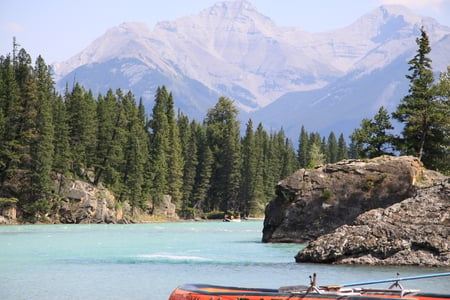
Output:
top-left (0, 0), bottom-right (450, 64)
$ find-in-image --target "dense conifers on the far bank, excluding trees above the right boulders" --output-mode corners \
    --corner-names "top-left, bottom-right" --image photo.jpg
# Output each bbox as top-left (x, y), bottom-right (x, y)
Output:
top-left (0, 49), bottom-right (347, 218)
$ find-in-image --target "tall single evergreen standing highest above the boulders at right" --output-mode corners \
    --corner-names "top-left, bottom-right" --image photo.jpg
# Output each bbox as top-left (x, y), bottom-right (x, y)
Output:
top-left (393, 27), bottom-right (441, 166)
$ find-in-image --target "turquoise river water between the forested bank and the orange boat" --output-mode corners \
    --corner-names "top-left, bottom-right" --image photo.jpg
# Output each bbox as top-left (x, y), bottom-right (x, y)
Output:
top-left (0, 221), bottom-right (450, 300)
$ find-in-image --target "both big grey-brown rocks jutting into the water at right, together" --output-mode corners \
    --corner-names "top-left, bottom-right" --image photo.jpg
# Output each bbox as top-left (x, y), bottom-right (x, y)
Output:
top-left (263, 156), bottom-right (450, 266)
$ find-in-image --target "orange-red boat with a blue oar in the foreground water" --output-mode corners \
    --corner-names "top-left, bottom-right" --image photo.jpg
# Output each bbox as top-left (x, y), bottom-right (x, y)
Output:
top-left (169, 273), bottom-right (450, 300)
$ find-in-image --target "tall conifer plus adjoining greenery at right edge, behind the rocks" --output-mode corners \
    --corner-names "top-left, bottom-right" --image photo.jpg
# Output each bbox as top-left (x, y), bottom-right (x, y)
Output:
top-left (393, 28), bottom-right (450, 169)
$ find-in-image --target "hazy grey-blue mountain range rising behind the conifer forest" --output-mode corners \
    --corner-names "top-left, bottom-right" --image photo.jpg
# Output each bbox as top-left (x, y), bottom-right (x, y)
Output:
top-left (53, 0), bottom-right (450, 139)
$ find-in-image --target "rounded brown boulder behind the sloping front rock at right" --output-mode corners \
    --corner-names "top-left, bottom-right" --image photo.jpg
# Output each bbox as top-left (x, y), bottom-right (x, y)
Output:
top-left (262, 156), bottom-right (444, 243)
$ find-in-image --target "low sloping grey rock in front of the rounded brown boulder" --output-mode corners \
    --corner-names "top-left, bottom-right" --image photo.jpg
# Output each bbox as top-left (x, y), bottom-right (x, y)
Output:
top-left (296, 179), bottom-right (450, 267)
